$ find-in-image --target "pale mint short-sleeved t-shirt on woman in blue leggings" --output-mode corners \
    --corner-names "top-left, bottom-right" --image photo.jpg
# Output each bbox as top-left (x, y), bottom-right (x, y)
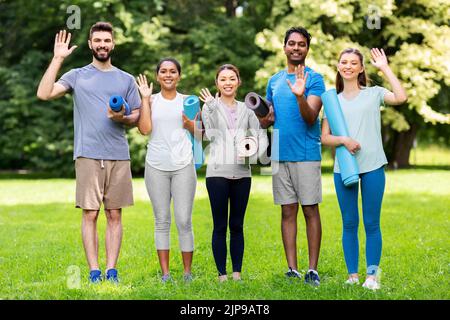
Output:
top-left (324, 86), bottom-right (388, 173)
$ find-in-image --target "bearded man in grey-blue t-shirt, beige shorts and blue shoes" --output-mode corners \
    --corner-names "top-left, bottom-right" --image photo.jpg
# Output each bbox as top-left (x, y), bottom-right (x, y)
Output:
top-left (37, 22), bottom-right (141, 283)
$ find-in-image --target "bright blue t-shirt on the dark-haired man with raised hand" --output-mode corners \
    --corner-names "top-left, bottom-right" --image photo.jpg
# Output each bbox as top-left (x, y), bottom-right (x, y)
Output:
top-left (266, 67), bottom-right (325, 162)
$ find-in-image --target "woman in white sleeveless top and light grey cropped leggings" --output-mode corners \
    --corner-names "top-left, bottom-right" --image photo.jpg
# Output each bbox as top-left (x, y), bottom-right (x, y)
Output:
top-left (137, 58), bottom-right (197, 282)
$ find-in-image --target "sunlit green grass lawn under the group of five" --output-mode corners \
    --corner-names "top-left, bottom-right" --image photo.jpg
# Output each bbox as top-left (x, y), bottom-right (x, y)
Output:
top-left (0, 146), bottom-right (450, 300)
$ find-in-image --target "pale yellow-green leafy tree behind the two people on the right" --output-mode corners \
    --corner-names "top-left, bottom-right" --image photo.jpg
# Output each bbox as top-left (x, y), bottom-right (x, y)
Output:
top-left (256, 0), bottom-right (450, 167)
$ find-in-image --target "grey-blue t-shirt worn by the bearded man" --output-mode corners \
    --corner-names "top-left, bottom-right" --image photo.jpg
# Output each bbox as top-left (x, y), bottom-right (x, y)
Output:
top-left (58, 64), bottom-right (141, 160)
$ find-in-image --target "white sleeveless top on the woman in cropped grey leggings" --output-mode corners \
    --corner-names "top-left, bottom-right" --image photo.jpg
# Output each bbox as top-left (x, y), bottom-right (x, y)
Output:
top-left (146, 92), bottom-right (192, 171)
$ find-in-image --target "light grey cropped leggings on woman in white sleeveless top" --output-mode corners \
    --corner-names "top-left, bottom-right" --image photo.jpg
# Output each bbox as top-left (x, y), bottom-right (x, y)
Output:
top-left (145, 163), bottom-right (197, 252)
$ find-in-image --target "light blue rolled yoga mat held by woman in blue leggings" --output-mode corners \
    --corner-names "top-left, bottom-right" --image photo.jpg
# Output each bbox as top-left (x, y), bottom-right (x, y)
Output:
top-left (321, 89), bottom-right (359, 187)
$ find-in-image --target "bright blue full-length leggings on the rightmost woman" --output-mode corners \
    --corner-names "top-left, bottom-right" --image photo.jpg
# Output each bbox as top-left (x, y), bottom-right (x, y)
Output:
top-left (334, 166), bottom-right (386, 275)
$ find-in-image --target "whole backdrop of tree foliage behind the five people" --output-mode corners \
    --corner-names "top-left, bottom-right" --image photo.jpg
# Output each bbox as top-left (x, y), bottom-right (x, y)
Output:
top-left (0, 0), bottom-right (450, 175)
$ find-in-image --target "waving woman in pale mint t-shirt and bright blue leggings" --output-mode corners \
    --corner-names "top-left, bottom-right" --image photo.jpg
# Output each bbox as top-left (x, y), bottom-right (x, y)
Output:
top-left (322, 48), bottom-right (407, 290)
